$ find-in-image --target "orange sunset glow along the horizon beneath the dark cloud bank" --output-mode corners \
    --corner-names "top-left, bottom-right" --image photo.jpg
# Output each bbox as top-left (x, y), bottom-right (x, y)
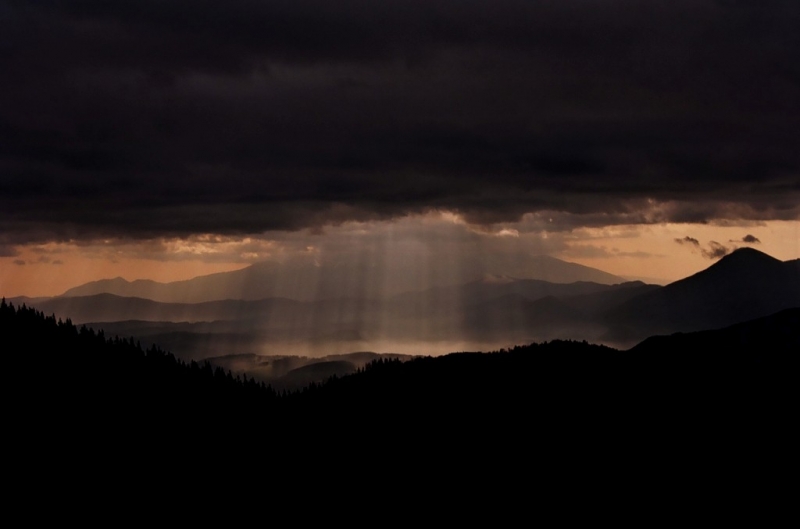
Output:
top-left (0, 214), bottom-right (800, 297)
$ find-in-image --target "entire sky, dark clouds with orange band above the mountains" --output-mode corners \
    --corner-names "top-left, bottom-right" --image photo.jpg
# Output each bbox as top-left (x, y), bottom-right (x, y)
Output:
top-left (0, 0), bottom-right (800, 296)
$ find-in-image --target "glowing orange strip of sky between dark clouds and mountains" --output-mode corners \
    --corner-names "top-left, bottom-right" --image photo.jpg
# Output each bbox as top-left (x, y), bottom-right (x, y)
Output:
top-left (0, 211), bottom-right (800, 297)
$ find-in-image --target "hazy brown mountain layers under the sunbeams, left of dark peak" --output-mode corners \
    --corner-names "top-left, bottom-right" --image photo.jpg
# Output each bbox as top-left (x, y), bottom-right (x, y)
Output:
top-left (7, 256), bottom-right (636, 360)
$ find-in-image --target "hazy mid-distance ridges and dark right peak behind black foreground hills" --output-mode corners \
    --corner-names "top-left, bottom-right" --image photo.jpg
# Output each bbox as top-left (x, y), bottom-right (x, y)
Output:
top-left (11, 249), bottom-right (800, 385)
